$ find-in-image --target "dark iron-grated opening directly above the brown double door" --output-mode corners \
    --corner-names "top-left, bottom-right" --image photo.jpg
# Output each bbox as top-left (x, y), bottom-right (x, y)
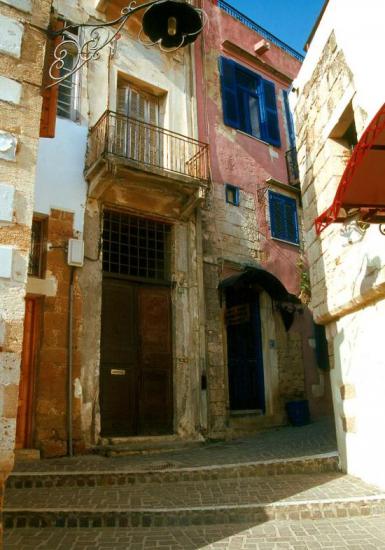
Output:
top-left (103, 211), bottom-right (171, 281)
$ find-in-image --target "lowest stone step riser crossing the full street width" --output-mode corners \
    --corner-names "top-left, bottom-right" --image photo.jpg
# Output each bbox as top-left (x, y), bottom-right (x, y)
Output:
top-left (3, 497), bottom-right (385, 529)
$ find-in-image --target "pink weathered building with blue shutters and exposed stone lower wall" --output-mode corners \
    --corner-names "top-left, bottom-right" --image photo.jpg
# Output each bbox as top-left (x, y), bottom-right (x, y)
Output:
top-left (196, 0), bottom-right (330, 436)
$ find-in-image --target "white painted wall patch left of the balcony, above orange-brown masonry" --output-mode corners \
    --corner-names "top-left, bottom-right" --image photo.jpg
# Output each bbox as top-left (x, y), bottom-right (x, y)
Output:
top-left (34, 118), bottom-right (88, 232)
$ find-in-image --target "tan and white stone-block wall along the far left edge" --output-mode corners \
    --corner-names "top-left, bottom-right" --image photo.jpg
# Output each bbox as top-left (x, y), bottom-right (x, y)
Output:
top-left (0, 0), bottom-right (52, 545)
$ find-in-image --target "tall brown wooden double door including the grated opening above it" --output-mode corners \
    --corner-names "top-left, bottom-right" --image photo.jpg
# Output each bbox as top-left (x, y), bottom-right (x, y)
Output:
top-left (100, 211), bottom-right (173, 437)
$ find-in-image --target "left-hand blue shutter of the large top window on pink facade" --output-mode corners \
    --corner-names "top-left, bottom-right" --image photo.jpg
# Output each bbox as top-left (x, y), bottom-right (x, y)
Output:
top-left (219, 57), bottom-right (240, 129)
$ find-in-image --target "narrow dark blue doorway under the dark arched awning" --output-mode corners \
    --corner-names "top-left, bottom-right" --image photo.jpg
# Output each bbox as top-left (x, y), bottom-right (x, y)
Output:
top-left (226, 286), bottom-right (265, 414)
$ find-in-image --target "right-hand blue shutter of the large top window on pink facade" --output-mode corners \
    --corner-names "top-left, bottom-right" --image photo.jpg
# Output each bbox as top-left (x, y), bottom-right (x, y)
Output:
top-left (259, 78), bottom-right (281, 147)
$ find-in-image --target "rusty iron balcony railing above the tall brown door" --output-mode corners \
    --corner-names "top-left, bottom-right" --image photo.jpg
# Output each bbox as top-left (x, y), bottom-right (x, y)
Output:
top-left (87, 111), bottom-right (209, 181)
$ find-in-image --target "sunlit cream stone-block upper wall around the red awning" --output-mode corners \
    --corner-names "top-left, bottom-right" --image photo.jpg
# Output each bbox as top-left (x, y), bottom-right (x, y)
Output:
top-left (295, 31), bottom-right (385, 323)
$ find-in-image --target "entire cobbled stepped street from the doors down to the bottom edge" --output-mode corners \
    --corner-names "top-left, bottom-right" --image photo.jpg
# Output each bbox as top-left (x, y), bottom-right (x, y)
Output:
top-left (3, 421), bottom-right (385, 550)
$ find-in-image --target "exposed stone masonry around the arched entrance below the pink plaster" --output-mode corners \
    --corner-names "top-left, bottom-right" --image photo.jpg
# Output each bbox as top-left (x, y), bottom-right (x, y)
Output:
top-left (202, 183), bottom-right (322, 437)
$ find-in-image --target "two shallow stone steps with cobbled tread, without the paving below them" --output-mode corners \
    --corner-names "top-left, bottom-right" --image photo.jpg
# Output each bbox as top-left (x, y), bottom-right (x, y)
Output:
top-left (4, 453), bottom-right (385, 529)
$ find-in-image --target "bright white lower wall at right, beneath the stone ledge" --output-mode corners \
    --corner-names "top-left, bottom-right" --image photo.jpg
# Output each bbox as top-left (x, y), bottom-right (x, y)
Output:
top-left (331, 300), bottom-right (385, 489)
